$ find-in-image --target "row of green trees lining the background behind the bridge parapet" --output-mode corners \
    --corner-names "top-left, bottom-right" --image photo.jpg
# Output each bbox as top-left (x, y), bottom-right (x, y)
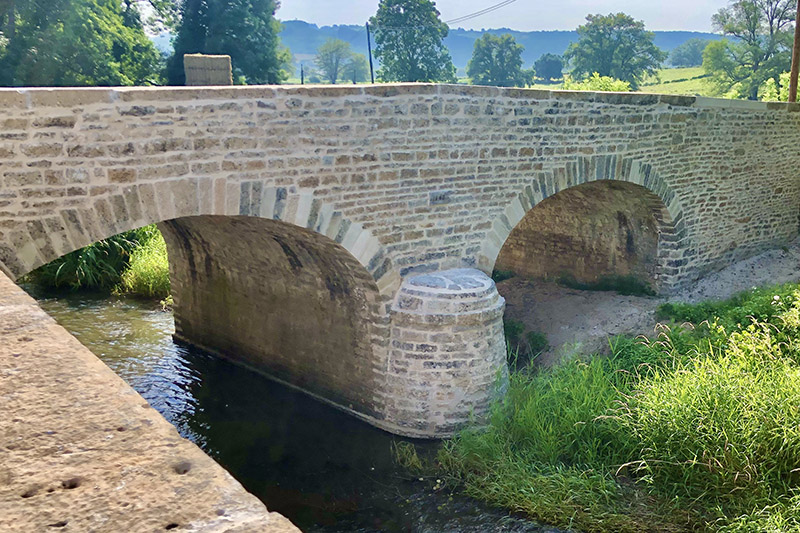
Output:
top-left (0, 0), bottom-right (795, 99)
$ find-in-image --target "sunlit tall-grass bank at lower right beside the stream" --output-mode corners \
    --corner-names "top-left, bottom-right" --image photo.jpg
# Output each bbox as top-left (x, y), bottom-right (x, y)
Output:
top-left (438, 285), bottom-right (800, 532)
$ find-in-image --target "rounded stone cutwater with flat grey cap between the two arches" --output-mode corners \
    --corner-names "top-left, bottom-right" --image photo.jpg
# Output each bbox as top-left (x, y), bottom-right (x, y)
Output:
top-left (386, 268), bottom-right (508, 436)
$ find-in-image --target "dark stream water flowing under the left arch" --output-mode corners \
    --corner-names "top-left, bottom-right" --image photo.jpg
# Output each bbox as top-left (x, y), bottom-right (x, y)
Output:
top-left (26, 287), bottom-right (557, 533)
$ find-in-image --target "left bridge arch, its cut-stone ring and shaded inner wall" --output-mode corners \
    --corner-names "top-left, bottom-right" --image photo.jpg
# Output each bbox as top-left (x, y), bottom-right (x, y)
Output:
top-left (9, 179), bottom-right (412, 427)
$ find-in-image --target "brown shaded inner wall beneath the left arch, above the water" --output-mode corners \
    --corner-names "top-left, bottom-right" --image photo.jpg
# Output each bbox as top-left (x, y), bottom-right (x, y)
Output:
top-left (159, 216), bottom-right (387, 419)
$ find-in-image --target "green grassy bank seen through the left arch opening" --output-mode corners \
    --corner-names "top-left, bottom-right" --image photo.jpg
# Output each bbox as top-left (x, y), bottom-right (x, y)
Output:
top-left (24, 225), bottom-right (169, 299)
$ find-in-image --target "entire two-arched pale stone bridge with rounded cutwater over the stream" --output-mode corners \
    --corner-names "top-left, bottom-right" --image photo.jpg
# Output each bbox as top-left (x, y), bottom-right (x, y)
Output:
top-left (0, 84), bottom-right (800, 437)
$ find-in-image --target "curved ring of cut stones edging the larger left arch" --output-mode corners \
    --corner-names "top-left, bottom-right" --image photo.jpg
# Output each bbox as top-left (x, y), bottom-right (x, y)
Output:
top-left (8, 178), bottom-right (400, 301)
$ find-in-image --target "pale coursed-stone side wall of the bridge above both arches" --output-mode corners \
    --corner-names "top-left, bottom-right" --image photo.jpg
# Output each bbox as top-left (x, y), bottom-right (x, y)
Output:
top-left (0, 84), bottom-right (800, 290)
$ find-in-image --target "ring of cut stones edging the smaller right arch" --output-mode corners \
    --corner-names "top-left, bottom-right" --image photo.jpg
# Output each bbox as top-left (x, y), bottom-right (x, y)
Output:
top-left (478, 155), bottom-right (691, 293)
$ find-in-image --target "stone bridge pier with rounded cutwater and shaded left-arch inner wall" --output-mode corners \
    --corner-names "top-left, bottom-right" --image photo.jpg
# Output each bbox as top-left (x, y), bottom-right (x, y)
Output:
top-left (159, 212), bottom-right (508, 437)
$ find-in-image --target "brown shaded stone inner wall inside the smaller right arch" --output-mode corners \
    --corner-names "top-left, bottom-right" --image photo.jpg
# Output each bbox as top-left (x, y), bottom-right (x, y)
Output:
top-left (495, 181), bottom-right (670, 294)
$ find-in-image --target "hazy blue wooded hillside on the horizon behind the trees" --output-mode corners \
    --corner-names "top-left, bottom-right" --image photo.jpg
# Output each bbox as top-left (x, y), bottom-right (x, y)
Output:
top-left (280, 20), bottom-right (721, 68)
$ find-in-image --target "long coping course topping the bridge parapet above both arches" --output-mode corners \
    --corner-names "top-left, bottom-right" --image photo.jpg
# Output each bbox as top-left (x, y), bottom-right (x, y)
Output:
top-left (0, 83), bottom-right (800, 112)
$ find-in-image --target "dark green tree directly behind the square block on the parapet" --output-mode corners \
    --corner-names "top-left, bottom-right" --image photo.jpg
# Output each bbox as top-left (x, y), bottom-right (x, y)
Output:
top-left (167, 0), bottom-right (291, 85)
